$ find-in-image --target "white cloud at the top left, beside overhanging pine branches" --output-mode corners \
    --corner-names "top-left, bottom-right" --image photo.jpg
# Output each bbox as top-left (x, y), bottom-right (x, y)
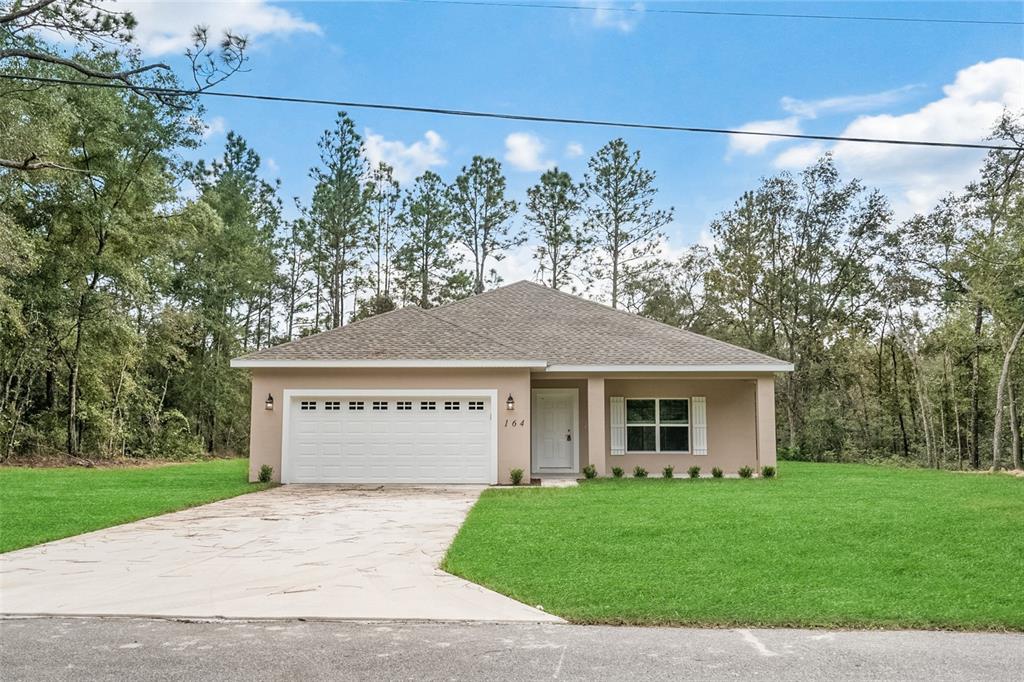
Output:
top-left (111, 0), bottom-right (322, 56)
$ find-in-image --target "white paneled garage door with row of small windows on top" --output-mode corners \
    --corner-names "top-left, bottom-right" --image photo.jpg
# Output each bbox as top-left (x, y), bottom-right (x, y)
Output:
top-left (283, 394), bottom-right (496, 483)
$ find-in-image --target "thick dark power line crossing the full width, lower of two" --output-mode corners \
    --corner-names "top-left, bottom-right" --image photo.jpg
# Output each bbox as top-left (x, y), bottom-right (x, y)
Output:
top-left (0, 74), bottom-right (1024, 152)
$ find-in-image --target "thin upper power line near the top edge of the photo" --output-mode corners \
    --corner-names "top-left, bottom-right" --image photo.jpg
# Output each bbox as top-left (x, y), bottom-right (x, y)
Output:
top-left (398, 0), bottom-right (1024, 26)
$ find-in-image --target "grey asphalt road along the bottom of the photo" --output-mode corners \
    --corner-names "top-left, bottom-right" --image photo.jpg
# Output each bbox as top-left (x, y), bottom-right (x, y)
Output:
top-left (0, 617), bottom-right (1024, 682)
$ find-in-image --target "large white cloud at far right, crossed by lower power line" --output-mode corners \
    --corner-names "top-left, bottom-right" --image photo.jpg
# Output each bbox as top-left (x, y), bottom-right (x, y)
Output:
top-left (775, 58), bottom-right (1024, 218)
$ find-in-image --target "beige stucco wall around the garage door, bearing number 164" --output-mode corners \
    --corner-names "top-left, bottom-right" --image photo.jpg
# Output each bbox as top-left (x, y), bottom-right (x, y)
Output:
top-left (249, 369), bottom-right (529, 483)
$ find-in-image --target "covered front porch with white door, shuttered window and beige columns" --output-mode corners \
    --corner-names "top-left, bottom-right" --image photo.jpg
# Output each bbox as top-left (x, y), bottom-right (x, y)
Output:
top-left (530, 373), bottom-right (775, 481)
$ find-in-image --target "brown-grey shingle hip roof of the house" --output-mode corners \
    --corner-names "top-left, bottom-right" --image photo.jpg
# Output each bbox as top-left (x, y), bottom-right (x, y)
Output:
top-left (234, 282), bottom-right (785, 369)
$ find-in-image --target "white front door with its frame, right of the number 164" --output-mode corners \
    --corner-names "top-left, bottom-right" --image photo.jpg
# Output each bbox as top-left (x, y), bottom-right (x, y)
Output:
top-left (530, 388), bottom-right (580, 473)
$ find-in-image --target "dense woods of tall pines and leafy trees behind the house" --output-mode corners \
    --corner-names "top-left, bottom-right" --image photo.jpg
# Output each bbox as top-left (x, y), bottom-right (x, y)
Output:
top-left (0, 3), bottom-right (1024, 468)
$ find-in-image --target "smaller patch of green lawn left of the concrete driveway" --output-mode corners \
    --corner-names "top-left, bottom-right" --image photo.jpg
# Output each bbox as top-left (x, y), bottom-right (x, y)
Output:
top-left (0, 460), bottom-right (267, 552)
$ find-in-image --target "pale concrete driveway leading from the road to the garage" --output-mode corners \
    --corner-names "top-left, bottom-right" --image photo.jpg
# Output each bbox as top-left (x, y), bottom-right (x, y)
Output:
top-left (0, 485), bottom-right (559, 622)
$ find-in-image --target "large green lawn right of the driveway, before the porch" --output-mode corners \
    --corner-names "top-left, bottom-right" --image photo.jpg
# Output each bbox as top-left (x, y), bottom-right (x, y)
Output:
top-left (444, 462), bottom-right (1024, 631)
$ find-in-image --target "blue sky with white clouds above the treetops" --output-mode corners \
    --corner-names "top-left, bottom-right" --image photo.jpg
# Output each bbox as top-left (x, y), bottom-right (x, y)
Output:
top-left (116, 0), bottom-right (1024, 281)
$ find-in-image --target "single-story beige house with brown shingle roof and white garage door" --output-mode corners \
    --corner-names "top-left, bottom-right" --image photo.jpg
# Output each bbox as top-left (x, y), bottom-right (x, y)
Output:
top-left (231, 282), bottom-right (793, 483)
